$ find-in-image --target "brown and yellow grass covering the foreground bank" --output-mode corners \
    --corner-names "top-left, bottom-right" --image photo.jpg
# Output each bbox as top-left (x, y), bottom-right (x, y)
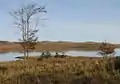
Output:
top-left (0, 57), bottom-right (120, 84)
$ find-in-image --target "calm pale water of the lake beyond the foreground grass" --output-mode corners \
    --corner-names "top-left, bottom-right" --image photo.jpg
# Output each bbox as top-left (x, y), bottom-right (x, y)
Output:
top-left (0, 49), bottom-right (120, 61)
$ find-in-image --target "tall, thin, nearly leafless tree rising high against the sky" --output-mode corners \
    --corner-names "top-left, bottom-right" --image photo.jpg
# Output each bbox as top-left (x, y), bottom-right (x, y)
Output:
top-left (11, 4), bottom-right (47, 57)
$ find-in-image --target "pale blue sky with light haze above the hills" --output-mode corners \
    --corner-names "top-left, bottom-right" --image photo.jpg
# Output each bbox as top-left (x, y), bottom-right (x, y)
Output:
top-left (0, 0), bottom-right (120, 43)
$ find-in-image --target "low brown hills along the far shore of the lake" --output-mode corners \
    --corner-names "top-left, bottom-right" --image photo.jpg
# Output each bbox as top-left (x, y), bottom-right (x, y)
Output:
top-left (0, 41), bottom-right (120, 52)
